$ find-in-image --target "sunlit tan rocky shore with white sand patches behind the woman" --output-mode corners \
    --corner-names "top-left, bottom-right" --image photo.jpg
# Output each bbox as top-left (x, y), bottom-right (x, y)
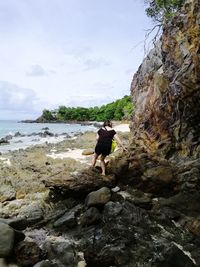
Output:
top-left (0, 124), bottom-right (129, 217)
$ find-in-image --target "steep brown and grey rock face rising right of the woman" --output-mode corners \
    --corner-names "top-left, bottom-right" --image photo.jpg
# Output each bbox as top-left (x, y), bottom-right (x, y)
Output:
top-left (131, 0), bottom-right (200, 158)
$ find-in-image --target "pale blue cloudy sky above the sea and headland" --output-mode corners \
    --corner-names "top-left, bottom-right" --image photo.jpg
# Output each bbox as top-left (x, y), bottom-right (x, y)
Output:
top-left (0, 0), bottom-right (151, 120)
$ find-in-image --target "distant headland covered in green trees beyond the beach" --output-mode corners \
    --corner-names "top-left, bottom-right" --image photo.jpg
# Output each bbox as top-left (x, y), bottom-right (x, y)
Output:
top-left (37, 95), bottom-right (133, 122)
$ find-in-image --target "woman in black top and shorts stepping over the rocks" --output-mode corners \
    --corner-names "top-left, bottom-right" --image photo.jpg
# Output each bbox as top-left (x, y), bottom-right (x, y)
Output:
top-left (92, 120), bottom-right (126, 175)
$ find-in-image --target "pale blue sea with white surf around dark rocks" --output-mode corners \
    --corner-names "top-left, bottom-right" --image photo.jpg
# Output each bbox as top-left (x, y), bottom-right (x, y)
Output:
top-left (0, 120), bottom-right (96, 153)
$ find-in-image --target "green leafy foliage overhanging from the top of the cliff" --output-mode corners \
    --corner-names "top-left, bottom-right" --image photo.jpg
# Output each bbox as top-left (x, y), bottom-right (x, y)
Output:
top-left (145, 0), bottom-right (185, 24)
